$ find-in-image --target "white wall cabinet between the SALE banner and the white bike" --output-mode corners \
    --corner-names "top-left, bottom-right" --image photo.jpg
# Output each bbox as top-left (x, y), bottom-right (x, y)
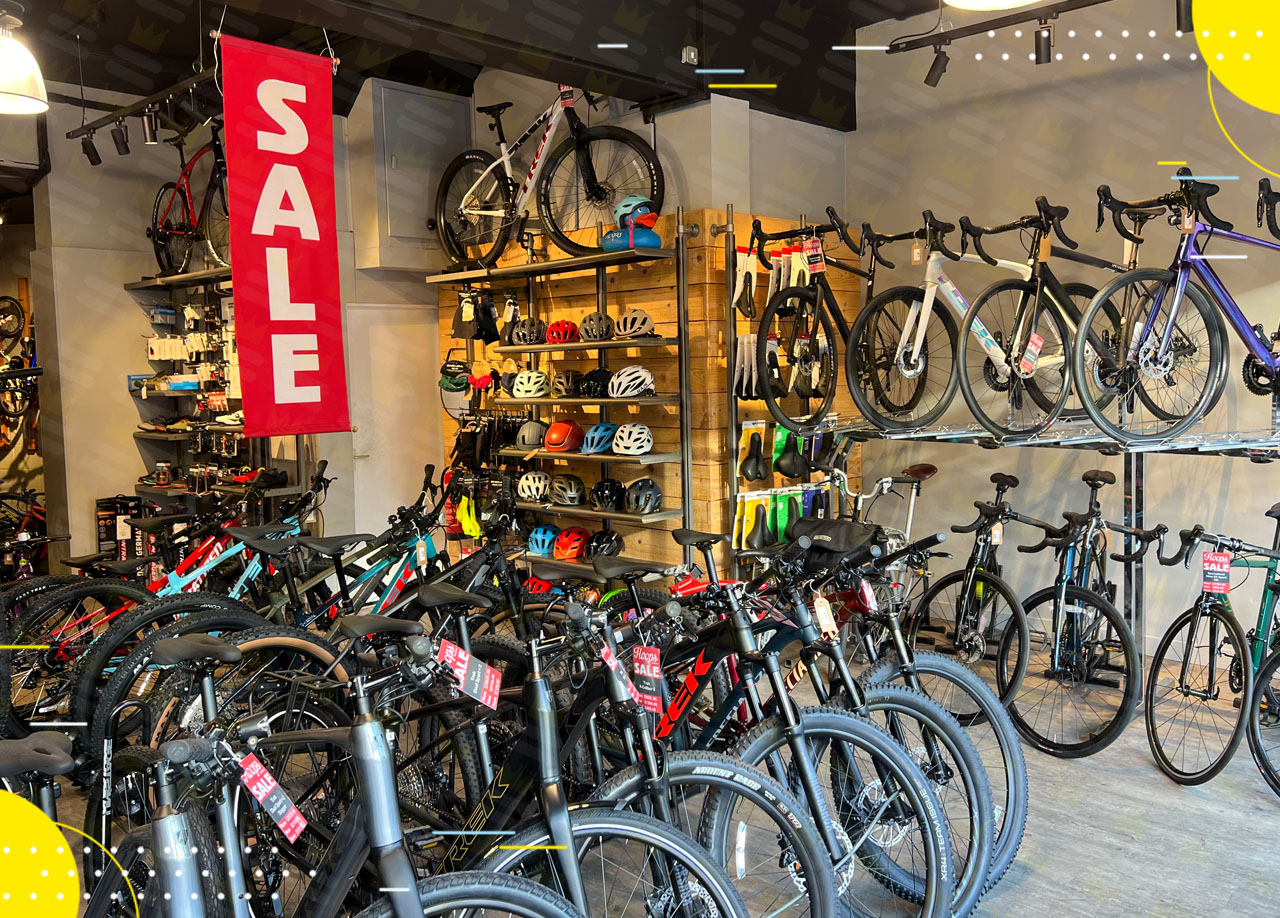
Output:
top-left (347, 79), bottom-right (472, 273)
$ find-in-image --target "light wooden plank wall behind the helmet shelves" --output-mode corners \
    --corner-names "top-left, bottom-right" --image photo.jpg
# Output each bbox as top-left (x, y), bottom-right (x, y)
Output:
top-left (439, 210), bottom-right (861, 563)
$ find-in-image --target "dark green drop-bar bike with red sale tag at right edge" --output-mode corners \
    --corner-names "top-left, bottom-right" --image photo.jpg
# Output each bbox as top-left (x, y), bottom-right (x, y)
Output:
top-left (1144, 514), bottom-right (1280, 785)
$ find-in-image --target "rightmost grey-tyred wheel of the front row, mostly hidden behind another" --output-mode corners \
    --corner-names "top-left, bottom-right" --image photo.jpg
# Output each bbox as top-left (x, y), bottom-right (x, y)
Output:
top-left (861, 650), bottom-right (1028, 889)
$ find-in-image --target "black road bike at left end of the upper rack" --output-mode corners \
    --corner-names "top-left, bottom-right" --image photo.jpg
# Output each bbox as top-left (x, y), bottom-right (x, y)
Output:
top-left (748, 207), bottom-right (918, 433)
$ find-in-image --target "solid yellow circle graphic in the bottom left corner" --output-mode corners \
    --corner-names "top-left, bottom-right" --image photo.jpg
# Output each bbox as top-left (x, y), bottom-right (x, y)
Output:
top-left (0, 790), bottom-right (81, 918)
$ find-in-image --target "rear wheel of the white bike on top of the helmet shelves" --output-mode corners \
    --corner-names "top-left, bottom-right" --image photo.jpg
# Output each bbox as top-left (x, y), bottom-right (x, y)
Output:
top-left (435, 150), bottom-right (515, 265)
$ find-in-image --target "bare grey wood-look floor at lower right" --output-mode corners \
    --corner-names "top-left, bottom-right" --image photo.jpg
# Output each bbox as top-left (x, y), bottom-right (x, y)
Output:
top-left (979, 717), bottom-right (1280, 918)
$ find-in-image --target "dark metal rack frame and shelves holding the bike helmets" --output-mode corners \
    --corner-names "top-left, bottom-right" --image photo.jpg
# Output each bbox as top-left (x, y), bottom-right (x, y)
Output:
top-left (426, 207), bottom-right (698, 572)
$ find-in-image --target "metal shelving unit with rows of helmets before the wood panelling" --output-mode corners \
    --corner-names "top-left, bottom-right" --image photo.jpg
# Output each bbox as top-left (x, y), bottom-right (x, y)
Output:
top-left (426, 209), bottom-right (699, 571)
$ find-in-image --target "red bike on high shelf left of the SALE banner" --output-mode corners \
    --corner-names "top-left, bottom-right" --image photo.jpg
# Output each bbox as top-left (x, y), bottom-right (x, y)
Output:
top-left (147, 118), bottom-right (230, 275)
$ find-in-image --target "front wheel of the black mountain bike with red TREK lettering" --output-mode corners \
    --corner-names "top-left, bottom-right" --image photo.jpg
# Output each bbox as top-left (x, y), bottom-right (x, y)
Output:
top-left (731, 707), bottom-right (955, 918)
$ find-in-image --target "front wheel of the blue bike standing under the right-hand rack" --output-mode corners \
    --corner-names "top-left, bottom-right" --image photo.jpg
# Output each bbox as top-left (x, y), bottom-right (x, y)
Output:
top-left (996, 584), bottom-right (1142, 758)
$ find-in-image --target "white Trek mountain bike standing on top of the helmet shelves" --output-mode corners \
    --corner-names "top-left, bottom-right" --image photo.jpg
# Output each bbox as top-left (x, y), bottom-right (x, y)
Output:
top-left (434, 83), bottom-right (664, 266)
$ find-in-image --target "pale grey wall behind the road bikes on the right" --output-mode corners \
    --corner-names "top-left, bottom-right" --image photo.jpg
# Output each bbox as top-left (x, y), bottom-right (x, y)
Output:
top-left (846, 0), bottom-right (1280, 647)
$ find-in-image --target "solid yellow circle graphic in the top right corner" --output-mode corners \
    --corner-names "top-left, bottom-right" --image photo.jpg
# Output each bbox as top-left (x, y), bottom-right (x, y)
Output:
top-left (1192, 0), bottom-right (1280, 114)
